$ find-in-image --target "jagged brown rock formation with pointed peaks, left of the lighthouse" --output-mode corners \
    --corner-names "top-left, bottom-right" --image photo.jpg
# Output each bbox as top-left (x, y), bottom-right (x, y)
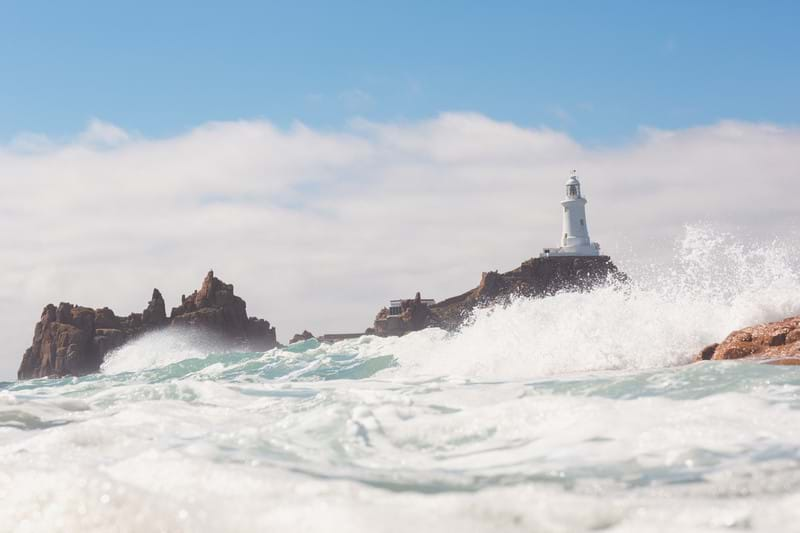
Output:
top-left (17, 271), bottom-right (277, 379)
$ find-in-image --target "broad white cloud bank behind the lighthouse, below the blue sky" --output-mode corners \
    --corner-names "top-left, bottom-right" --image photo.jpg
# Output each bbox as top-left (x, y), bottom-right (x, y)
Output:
top-left (0, 113), bottom-right (800, 378)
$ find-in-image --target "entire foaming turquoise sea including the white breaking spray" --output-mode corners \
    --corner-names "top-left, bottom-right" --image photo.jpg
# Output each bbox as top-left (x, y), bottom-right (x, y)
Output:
top-left (0, 228), bottom-right (800, 533)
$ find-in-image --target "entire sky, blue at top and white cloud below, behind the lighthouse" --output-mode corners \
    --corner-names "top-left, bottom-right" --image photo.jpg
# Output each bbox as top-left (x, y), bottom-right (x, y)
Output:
top-left (0, 0), bottom-right (800, 379)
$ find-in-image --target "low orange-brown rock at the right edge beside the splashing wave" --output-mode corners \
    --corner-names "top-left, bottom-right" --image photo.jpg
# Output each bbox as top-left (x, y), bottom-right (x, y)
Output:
top-left (695, 316), bottom-right (800, 365)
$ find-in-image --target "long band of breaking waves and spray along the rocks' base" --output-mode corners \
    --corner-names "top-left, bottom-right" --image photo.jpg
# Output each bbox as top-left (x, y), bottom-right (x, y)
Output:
top-left (98, 227), bottom-right (800, 380)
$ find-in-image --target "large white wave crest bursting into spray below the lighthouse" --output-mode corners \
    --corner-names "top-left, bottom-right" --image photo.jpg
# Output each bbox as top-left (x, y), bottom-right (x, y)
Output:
top-left (383, 227), bottom-right (800, 379)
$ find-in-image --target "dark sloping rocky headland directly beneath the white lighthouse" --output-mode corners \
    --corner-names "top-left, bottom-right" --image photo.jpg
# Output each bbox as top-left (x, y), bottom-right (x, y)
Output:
top-left (367, 256), bottom-right (627, 336)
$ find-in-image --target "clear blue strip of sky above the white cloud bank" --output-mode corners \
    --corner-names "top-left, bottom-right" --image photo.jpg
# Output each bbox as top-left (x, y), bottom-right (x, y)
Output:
top-left (0, 0), bottom-right (800, 145)
